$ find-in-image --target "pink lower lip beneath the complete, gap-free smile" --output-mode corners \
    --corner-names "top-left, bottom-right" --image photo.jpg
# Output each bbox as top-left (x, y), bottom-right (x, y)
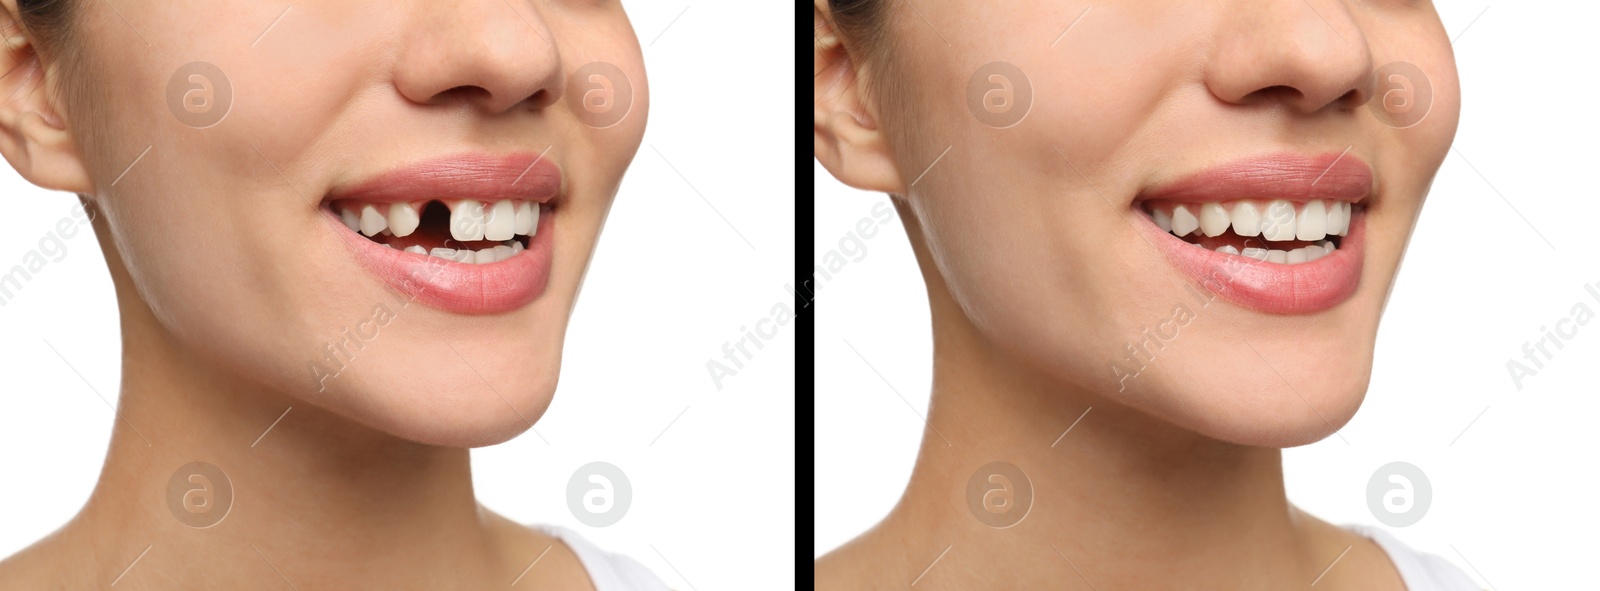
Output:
top-left (1141, 210), bottom-right (1366, 314)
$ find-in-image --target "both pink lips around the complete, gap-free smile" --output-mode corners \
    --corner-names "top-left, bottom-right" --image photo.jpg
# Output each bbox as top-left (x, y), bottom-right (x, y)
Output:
top-left (1134, 154), bottom-right (1373, 314)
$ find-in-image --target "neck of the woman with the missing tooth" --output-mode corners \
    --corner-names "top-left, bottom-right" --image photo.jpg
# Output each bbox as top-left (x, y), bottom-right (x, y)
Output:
top-left (69, 275), bottom-right (515, 588)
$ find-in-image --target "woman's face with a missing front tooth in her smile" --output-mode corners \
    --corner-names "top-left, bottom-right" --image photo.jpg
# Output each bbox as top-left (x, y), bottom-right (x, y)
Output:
top-left (45, 0), bottom-right (648, 445)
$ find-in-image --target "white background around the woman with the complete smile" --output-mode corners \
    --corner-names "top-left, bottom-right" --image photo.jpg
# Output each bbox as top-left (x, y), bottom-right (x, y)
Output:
top-left (813, 0), bottom-right (1600, 589)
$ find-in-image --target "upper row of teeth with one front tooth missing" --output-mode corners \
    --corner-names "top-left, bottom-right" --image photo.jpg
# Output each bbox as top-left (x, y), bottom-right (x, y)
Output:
top-left (339, 199), bottom-right (539, 242)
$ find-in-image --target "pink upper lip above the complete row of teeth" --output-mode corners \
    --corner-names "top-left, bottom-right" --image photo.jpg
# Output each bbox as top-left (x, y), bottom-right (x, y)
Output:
top-left (1134, 151), bottom-right (1373, 203)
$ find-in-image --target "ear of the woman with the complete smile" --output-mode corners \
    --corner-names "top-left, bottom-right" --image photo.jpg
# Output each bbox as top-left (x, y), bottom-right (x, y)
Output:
top-left (813, 0), bottom-right (906, 195)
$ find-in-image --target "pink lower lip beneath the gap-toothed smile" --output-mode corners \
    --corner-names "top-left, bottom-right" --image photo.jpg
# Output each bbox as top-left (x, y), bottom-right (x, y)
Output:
top-left (323, 210), bottom-right (557, 314)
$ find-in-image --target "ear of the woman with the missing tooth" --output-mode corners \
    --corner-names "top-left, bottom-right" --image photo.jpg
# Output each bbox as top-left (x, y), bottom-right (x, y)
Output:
top-left (0, 0), bottom-right (94, 195)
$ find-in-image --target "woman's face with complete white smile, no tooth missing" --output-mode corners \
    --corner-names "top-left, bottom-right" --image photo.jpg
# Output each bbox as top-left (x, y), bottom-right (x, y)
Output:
top-left (844, 0), bottom-right (1459, 447)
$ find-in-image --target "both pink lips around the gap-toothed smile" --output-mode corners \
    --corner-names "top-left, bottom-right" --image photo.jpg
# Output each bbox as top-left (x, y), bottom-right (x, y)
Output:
top-left (322, 154), bottom-right (562, 314)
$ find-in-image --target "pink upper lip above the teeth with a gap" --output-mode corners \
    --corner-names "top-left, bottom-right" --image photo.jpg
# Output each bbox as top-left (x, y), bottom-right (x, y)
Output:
top-left (325, 154), bottom-right (562, 203)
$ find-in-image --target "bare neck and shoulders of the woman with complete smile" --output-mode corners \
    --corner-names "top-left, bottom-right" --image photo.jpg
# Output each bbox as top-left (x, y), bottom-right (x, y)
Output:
top-left (816, 213), bottom-right (1405, 591)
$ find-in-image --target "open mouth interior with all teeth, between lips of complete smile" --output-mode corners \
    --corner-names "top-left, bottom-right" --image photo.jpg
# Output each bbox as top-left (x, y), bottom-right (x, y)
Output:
top-left (1141, 200), bottom-right (1360, 264)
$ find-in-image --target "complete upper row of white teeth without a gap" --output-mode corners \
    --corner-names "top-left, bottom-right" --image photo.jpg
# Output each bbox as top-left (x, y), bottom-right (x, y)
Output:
top-left (1150, 199), bottom-right (1350, 240)
